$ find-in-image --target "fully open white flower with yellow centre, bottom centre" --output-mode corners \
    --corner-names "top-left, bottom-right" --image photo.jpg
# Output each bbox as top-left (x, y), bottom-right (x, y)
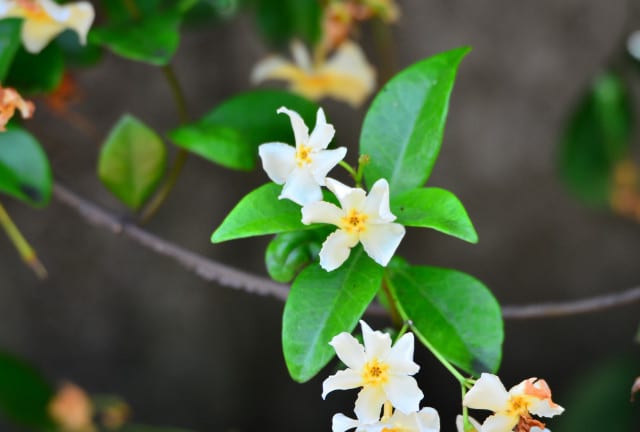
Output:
top-left (322, 321), bottom-right (423, 424)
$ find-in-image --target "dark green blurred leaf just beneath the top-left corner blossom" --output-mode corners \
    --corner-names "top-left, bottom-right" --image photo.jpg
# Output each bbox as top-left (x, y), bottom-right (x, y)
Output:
top-left (3, 43), bottom-right (64, 93)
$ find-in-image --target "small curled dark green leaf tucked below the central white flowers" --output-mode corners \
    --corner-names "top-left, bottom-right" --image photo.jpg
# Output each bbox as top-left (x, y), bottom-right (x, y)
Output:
top-left (265, 227), bottom-right (335, 283)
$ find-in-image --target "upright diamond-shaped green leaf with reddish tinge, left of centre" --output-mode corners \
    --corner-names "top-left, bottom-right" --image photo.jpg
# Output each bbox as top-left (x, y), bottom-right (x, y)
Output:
top-left (98, 114), bottom-right (167, 210)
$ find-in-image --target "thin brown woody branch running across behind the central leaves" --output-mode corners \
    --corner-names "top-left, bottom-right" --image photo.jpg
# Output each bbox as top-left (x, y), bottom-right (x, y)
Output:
top-left (53, 183), bottom-right (640, 319)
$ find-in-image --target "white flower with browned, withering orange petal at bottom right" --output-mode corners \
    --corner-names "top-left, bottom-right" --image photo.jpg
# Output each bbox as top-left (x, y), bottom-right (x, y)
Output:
top-left (462, 373), bottom-right (564, 432)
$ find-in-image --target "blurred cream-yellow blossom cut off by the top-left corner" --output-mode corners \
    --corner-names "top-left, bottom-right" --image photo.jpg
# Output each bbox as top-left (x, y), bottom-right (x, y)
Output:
top-left (0, 0), bottom-right (95, 53)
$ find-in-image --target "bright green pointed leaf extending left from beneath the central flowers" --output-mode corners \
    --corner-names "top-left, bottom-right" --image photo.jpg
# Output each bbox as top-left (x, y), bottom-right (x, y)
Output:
top-left (211, 183), bottom-right (315, 243)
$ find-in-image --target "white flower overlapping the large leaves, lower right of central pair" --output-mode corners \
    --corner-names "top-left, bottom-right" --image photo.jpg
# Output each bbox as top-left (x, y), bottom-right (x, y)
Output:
top-left (302, 178), bottom-right (405, 271)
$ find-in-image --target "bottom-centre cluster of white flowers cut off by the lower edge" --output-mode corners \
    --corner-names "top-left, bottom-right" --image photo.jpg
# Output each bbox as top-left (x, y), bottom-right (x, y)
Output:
top-left (322, 321), bottom-right (440, 432)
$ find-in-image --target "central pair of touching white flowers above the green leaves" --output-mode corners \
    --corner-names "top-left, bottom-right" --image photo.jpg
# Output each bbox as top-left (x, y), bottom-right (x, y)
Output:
top-left (258, 107), bottom-right (405, 271)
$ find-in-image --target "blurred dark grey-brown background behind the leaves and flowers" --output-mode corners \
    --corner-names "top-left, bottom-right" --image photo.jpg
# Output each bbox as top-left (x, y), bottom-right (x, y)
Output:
top-left (0, 0), bottom-right (640, 432)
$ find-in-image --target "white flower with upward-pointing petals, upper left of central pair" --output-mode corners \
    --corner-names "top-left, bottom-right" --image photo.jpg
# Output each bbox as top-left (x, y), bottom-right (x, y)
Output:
top-left (258, 107), bottom-right (347, 205)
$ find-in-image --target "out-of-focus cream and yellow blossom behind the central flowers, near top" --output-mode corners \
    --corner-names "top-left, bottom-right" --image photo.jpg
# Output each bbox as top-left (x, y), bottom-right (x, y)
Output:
top-left (251, 41), bottom-right (375, 106)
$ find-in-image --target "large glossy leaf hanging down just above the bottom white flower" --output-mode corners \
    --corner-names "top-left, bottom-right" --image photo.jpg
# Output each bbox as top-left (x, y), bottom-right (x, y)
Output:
top-left (282, 246), bottom-right (384, 382)
